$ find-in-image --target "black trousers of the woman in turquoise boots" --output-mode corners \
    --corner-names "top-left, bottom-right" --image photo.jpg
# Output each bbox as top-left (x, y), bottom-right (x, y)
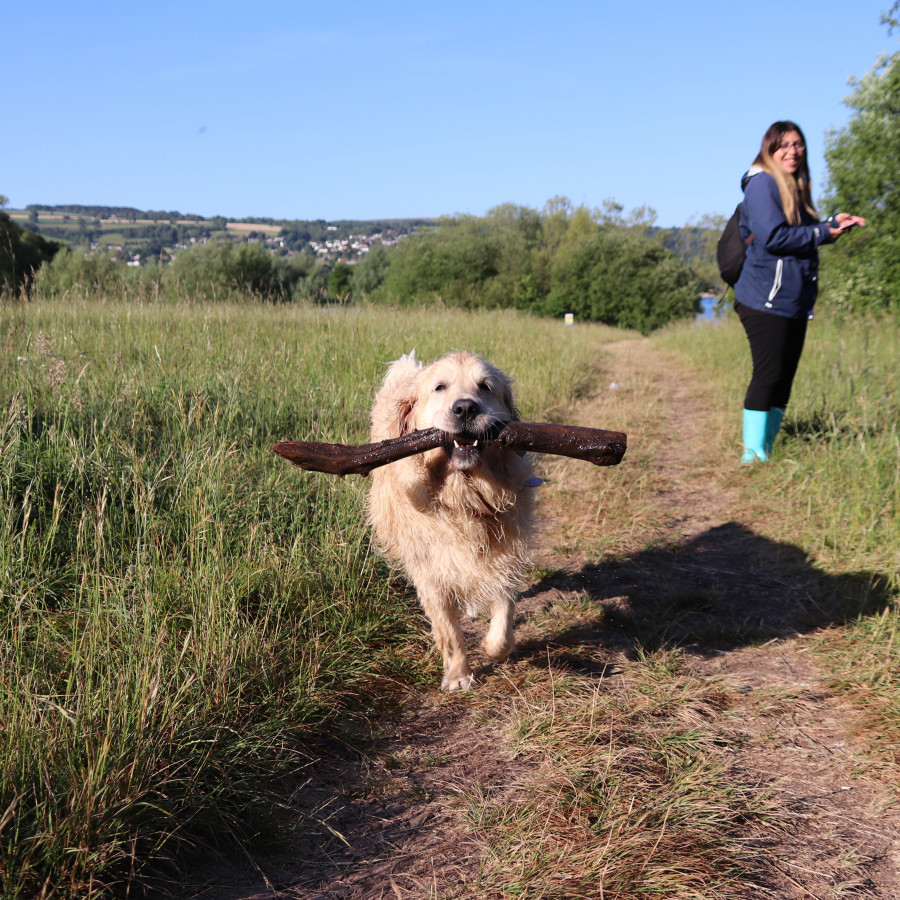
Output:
top-left (734, 303), bottom-right (808, 412)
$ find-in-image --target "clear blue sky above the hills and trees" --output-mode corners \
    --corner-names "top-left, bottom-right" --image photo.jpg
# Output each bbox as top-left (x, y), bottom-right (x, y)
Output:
top-left (0, 0), bottom-right (898, 226)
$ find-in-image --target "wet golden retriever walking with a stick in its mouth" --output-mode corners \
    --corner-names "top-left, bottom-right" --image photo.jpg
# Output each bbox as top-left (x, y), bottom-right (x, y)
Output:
top-left (369, 352), bottom-right (537, 692)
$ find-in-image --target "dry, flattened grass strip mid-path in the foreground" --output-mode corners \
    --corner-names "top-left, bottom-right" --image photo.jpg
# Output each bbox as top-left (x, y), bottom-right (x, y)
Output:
top-left (465, 652), bottom-right (764, 900)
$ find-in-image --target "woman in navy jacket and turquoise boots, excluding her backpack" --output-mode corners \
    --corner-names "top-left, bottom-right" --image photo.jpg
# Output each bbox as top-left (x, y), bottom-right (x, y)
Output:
top-left (734, 122), bottom-right (866, 463)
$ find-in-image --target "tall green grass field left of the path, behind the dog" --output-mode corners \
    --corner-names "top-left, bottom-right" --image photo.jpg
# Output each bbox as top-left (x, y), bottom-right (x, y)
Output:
top-left (0, 299), bottom-right (632, 897)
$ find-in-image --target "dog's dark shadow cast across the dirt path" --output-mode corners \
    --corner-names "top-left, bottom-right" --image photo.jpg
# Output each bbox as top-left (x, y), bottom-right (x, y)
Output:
top-left (519, 522), bottom-right (890, 674)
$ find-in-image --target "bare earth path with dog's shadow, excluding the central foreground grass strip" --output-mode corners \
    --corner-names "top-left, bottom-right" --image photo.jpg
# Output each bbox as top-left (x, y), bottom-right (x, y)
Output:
top-left (183, 340), bottom-right (900, 900)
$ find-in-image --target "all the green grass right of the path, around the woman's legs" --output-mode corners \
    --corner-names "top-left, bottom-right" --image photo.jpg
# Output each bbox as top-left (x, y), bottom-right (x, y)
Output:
top-left (655, 313), bottom-right (900, 767)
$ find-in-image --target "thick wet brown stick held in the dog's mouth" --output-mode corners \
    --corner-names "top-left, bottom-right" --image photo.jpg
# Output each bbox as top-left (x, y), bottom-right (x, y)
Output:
top-left (273, 422), bottom-right (627, 476)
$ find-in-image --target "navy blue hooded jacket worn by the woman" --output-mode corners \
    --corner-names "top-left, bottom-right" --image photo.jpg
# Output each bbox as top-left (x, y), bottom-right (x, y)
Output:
top-left (734, 166), bottom-right (831, 319)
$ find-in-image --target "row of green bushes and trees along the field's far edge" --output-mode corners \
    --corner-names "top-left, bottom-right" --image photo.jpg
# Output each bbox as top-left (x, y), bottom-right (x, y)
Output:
top-left (7, 198), bottom-right (704, 333)
